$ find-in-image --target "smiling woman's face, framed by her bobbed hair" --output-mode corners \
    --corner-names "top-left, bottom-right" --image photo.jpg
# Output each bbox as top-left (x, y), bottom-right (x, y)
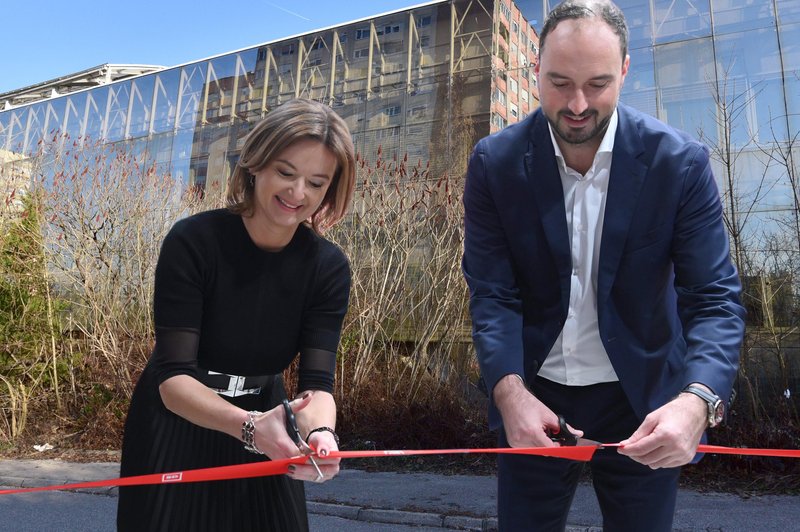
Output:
top-left (253, 139), bottom-right (337, 243)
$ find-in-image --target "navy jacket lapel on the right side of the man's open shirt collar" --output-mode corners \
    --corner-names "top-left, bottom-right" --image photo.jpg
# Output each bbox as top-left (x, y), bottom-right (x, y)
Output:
top-left (597, 106), bottom-right (647, 302)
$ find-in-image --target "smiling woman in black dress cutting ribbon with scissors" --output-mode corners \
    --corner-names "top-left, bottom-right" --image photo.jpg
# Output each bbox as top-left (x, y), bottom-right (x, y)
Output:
top-left (117, 99), bottom-right (355, 531)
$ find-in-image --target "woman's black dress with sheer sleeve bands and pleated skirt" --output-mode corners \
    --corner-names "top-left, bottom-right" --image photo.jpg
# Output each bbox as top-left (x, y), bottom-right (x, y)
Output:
top-left (117, 210), bottom-right (350, 532)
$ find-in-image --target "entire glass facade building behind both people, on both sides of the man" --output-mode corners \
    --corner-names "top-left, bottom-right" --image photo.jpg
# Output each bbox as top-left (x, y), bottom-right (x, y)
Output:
top-left (0, 0), bottom-right (800, 247)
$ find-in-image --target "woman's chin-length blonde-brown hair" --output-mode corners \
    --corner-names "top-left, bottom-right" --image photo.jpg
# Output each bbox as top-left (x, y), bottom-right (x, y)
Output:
top-left (226, 98), bottom-right (356, 233)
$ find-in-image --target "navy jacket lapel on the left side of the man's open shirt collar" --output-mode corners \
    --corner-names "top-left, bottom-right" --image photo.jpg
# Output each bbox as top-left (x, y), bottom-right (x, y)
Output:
top-left (525, 114), bottom-right (572, 305)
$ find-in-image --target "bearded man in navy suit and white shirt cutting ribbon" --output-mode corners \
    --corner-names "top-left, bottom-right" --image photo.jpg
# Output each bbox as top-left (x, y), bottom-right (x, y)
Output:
top-left (463, 0), bottom-right (744, 532)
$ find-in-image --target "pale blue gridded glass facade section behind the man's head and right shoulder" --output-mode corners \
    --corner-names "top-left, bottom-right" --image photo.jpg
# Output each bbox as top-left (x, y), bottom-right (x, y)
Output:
top-left (517, 0), bottom-right (800, 241)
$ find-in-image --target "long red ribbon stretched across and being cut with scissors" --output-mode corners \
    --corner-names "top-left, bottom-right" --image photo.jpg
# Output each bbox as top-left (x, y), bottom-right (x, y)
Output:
top-left (0, 444), bottom-right (800, 495)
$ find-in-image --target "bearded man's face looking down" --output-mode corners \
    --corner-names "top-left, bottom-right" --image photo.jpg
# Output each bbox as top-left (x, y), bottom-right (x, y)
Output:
top-left (535, 18), bottom-right (629, 151)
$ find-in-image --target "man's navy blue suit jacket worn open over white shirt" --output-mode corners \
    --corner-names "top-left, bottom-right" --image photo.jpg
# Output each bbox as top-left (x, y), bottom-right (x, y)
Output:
top-left (462, 104), bottom-right (744, 428)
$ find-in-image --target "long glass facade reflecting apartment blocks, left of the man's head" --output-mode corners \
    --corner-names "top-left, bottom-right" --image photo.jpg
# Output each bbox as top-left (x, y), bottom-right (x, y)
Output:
top-left (0, 0), bottom-right (538, 195)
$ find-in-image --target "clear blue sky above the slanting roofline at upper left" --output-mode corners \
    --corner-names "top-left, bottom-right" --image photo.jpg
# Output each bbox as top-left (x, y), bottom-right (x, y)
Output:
top-left (0, 0), bottom-right (426, 93)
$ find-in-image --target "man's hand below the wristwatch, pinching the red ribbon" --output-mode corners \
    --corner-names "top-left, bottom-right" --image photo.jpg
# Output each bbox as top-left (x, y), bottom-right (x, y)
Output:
top-left (619, 393), bottom-right (708, 469)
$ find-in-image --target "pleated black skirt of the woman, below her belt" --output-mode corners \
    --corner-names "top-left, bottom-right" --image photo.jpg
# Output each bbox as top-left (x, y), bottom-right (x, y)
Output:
top-left (117, 366), bottom-right (308, 532)
